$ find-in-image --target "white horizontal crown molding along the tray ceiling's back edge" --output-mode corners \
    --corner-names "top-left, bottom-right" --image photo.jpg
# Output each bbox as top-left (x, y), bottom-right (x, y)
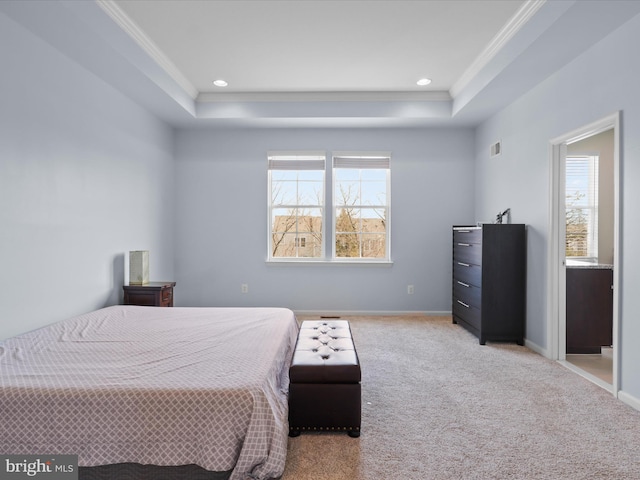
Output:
top-left (196, 90), bottom-right (451, 103)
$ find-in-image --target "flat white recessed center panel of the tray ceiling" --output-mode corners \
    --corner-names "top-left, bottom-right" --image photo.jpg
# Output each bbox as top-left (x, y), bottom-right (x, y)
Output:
top-left (109, 0), bottom-right (525, 98)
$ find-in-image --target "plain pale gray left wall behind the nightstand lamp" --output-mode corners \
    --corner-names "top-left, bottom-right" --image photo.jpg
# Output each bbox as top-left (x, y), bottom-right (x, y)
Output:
top-left (0, 14), bottom-right (173, 339)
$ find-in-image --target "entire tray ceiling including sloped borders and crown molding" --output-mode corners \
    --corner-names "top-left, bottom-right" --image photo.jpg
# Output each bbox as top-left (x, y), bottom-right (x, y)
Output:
top-left (0, 0), bottom-right (640, 128)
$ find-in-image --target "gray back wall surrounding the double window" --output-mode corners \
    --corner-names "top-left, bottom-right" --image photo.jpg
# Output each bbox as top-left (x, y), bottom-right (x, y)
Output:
top-left (175, 129), bottom-right (474, 312)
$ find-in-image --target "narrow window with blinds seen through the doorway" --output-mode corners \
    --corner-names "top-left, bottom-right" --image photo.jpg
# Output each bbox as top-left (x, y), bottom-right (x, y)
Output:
top-left (565, 156), bottom-right (599, 259)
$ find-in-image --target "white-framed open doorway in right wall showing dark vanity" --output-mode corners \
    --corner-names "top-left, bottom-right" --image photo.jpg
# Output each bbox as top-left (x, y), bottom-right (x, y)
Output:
top-left (548, 113), bottom-right (620, 396)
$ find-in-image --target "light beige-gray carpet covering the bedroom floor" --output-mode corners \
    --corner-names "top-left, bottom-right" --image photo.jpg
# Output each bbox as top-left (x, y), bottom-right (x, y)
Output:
top-left (282, 316), bottom-right (640, 480)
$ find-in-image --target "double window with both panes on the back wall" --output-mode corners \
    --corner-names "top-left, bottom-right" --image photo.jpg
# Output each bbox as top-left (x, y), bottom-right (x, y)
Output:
top-left (268, 152), bottom-right (390, 262)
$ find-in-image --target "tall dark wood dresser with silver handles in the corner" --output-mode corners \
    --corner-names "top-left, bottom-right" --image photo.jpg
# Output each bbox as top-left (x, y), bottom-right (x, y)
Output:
top-left (452, 224), bottom-right (527, 345)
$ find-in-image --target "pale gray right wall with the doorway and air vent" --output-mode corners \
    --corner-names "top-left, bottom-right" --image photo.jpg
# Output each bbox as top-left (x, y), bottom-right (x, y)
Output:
top-left (476, 13), bottom-right (640, 398)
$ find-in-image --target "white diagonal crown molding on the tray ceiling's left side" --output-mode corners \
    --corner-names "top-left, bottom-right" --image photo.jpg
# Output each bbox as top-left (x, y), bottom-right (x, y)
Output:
top-left (95, 0), bottom-right (198, 100)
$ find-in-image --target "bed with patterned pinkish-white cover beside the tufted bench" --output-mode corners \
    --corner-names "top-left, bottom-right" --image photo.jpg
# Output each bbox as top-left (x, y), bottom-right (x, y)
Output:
top-left (0, 306), bottom-right (298, 480)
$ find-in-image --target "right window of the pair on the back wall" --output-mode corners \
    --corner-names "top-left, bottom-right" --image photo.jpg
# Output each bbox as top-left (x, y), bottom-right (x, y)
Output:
top-left (333, 155), bottom-right (390, 260)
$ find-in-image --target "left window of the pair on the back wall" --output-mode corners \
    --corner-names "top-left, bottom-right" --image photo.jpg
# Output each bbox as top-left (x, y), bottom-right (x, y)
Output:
top-left (268, 153), bottom-right (325, 259)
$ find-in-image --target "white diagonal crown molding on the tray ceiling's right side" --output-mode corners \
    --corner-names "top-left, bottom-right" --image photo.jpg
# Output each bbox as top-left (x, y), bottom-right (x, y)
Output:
top-left (449, 0), bottom-right (547, 98)
